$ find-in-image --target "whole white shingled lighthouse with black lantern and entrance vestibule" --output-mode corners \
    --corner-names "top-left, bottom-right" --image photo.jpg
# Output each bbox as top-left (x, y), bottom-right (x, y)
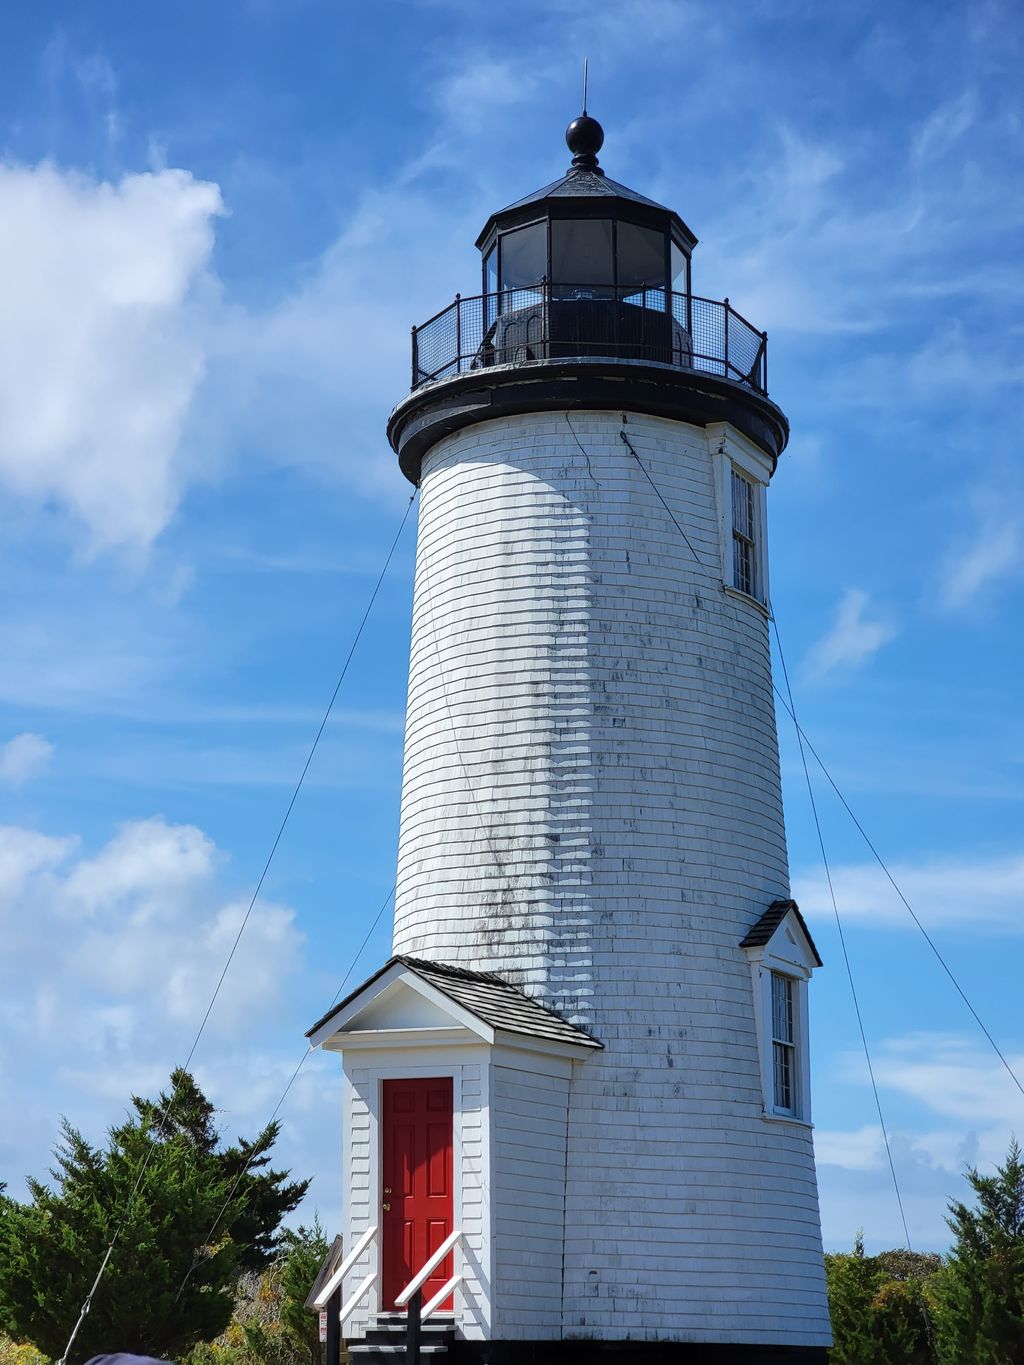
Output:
top-left (310, 115), bottom-right (830, 1365)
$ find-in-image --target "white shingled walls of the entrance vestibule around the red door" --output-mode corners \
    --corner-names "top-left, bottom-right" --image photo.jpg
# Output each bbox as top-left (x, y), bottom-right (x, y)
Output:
top-left (336, 1035), bottom-right (587, 1340)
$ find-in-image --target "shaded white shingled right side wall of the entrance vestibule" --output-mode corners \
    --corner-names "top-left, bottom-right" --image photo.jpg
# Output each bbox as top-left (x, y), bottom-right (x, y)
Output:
top-left (492, 1066), bottom-right (569, 1339)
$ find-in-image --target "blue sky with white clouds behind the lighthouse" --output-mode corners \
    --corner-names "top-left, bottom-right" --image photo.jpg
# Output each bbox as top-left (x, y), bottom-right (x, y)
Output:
top-left (0, 0), bottom-right (1024, 1248)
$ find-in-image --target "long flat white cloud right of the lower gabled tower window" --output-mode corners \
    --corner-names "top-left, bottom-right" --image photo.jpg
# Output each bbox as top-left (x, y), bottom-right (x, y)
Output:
top-left (795, 853), bottom-right (1024, 934)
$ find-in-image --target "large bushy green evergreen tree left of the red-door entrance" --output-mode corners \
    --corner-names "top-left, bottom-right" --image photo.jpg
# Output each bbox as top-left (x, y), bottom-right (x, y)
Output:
top-left (0, 1072), bottom-right (307, 1362)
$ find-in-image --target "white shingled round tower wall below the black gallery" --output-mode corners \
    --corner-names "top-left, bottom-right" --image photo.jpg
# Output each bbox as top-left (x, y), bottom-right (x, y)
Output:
top-left (395, 411), bottom-right (829, 1346)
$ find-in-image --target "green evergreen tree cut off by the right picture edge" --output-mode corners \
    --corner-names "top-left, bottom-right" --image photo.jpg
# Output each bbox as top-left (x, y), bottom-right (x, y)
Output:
top-left (937, 1138), bottom-right (1024, 1365)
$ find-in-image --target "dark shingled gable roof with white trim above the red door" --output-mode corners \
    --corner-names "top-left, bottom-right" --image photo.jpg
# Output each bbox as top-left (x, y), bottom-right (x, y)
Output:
top-left (306, 957), bottom-right (605, 1050)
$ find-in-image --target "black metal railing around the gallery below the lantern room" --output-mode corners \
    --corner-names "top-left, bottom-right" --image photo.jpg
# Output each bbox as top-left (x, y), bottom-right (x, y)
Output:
top-left (412, 281), bottom-right (767, 393)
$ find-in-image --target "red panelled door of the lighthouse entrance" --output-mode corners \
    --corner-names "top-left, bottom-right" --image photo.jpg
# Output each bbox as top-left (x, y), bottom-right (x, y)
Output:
top-left (381, 1076), bottom-right (455, 1309)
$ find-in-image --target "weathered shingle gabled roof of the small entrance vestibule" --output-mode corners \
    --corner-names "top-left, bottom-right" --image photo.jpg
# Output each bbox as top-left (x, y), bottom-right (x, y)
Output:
top-left (306, 956), bottom-right (603, 1051)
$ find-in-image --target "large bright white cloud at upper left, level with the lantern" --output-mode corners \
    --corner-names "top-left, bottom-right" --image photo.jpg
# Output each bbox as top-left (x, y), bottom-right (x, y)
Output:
top-left (0, 164), bottom-right (223, 547)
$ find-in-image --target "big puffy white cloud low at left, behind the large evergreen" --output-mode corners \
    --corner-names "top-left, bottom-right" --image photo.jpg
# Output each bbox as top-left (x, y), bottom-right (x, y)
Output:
top-left (0, 816), bottom-right (340, 1223)
